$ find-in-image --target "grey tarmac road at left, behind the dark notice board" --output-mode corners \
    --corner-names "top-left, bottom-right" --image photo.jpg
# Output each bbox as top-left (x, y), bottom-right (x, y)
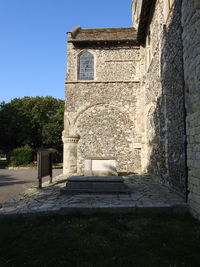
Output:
top-left (0, 169), bottom-right (62, 203)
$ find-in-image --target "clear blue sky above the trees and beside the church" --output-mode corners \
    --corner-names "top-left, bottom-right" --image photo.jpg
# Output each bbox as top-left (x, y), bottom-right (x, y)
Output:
top-left (0, 0), bottom-right (131, 102)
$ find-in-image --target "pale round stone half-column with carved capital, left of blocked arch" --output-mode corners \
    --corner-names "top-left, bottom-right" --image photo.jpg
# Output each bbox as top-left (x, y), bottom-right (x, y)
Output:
top-left (63, 136), bottom-right (80, 175)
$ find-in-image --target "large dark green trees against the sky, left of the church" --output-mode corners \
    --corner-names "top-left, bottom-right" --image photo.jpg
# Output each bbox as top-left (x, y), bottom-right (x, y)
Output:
top-left (0, 96), bottom-right (64, 151)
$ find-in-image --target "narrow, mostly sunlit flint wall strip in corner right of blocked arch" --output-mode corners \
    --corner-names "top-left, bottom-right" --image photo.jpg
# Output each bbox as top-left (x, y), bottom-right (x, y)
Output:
top-left (143, 1), bottom-right (167, 180)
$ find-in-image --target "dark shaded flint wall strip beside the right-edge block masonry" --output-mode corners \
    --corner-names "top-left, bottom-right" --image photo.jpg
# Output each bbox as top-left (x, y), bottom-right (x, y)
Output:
top-left (161, 0), bottom-right (187, 195)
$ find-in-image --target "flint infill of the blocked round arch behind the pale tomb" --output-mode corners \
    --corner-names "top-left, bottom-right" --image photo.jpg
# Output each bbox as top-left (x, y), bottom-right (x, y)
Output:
top-left (74, 103), bottom-right (139, 172)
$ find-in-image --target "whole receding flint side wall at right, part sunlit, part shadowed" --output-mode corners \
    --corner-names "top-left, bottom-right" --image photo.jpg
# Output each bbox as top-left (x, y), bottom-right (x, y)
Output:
top-left (143, 0), bottom-right (186, 195)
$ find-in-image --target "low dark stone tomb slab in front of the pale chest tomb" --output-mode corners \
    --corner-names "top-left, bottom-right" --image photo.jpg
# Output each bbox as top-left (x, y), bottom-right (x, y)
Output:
top-left (62, 176), bottom-right (131, 194)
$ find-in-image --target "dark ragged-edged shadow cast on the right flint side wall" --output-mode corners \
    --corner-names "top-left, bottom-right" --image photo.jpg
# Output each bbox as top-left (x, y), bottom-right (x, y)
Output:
top-left (146, 0), bottom-right (186, 195)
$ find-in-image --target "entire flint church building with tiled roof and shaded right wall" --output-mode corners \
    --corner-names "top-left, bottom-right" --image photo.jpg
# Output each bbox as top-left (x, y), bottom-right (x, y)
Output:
top-left (63, 0), bottom-right (200, 221)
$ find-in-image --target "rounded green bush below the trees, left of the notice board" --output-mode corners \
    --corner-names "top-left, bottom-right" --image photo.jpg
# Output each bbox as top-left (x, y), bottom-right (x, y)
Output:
top-left (9, 145), bottom-right (34, 166)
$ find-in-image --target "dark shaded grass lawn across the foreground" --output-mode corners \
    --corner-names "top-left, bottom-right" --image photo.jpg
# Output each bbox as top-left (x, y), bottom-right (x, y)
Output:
top-left (0, 215), bottom-right (200, 267)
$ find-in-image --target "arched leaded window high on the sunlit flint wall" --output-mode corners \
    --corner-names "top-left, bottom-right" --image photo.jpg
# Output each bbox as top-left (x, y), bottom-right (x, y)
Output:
top-left (78, 52), bottom-right (94, 80)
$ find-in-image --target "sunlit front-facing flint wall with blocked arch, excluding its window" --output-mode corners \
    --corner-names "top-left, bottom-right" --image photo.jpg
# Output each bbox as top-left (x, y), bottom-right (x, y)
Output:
top-left (65, 44), bottom-right (141, 172)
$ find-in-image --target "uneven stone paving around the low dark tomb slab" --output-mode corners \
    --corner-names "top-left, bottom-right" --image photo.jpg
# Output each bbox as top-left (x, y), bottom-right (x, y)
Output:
top-left (0, 176), bottom-right (187, 216)
